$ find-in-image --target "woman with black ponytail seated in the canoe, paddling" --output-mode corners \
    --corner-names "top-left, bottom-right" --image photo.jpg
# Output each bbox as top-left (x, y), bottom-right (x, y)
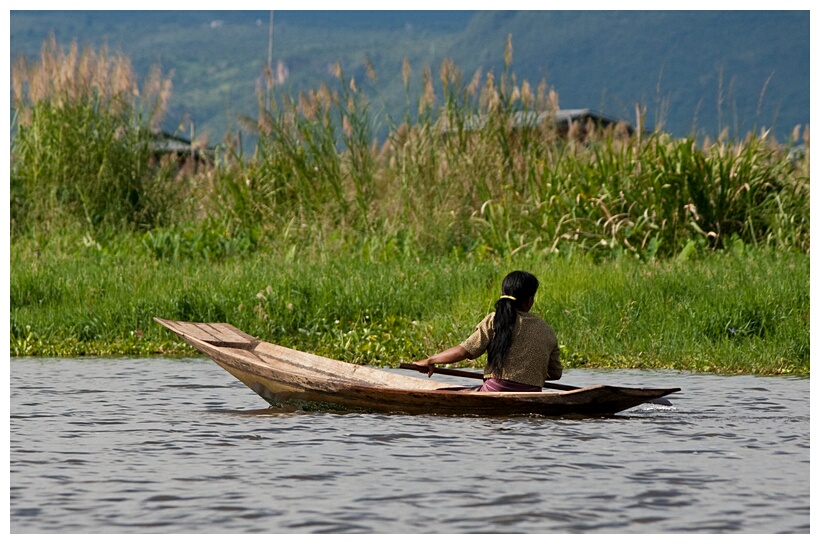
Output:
top-left (415, 270), bottom-right (563, 392)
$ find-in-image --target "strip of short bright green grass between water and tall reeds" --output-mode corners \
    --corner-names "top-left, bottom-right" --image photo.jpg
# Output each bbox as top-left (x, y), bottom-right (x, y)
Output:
top-left (11, 236), bottom-right (810, 374)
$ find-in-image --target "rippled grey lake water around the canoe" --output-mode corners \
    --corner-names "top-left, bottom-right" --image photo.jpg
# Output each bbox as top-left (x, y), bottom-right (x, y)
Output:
top-left (9, 358), bottom-right (810, 533)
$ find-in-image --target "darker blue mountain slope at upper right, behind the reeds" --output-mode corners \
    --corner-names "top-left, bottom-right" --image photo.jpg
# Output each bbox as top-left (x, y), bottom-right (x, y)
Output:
top-left (453, 11), bottom-right (810, 139)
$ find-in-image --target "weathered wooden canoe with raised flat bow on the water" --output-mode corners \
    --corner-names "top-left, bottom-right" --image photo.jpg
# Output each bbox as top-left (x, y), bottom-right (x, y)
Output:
top-left (154, 317), bottom-right (680, 416)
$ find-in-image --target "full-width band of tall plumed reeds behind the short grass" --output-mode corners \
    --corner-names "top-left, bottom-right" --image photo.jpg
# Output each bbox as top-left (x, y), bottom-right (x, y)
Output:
top-left (11, 38), bottom-right (810, 260)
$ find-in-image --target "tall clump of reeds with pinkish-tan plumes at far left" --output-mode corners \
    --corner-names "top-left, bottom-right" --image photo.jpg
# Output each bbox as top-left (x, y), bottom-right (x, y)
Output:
top-left (11, 36), bottom-right (184, 235)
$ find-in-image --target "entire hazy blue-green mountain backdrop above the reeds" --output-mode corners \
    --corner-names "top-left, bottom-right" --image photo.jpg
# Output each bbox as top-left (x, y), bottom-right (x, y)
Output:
top-left (10, 11), bottom-right (810, 142)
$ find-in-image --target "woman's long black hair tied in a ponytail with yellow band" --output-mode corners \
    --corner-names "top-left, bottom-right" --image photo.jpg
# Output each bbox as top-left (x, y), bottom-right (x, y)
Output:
top-left (487, 270), bottom-right (538, 375)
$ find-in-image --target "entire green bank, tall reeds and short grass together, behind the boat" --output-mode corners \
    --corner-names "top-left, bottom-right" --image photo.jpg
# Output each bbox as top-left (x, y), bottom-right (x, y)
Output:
top-left (10, 40), bottom-right (810, 374)
